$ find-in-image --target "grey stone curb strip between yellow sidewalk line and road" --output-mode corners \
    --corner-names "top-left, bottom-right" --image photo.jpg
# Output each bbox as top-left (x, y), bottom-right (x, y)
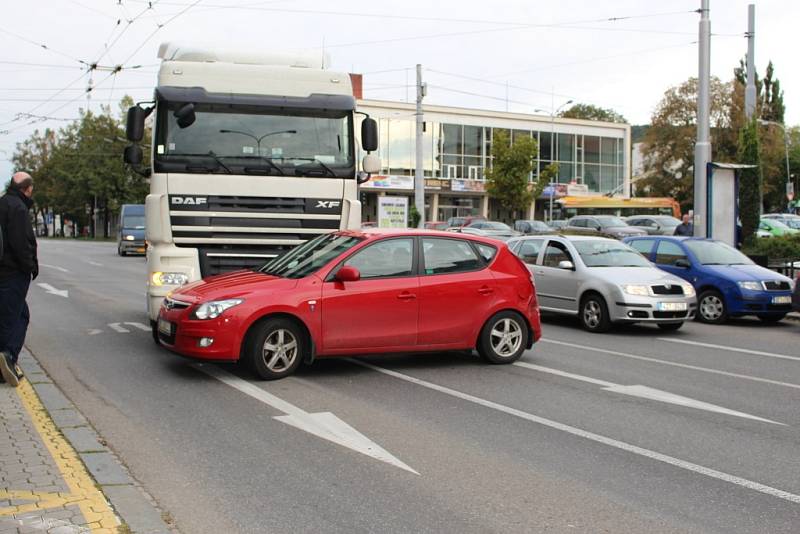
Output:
top-left (19, 348), bottom-right (178, 534)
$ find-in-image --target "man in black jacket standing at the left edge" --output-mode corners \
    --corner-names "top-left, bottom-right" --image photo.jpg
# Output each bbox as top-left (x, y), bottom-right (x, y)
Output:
top-left (0, 172), bottom-right (39, 387)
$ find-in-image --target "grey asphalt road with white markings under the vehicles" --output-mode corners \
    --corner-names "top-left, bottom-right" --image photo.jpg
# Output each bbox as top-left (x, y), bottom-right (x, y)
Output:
top-left (21, 240), bottom-right (800, 534)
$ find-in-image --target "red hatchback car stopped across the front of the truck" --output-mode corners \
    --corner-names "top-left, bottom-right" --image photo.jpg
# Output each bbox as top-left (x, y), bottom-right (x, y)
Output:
top-left (157, 229), bottom-right (541, 379)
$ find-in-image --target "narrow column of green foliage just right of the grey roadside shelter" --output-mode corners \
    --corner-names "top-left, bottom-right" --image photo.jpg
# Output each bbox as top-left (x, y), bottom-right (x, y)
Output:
top-left (738, 117), bottom-right (761, 245)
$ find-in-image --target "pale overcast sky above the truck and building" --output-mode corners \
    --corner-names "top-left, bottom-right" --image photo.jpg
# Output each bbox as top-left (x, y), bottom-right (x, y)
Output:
top-left (0, 0), bottom-right (800, 181)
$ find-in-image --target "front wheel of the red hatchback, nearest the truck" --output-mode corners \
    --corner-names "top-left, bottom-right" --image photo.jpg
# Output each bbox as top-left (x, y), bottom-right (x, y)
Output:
top-left (246, 319), bottom-right (308, 380)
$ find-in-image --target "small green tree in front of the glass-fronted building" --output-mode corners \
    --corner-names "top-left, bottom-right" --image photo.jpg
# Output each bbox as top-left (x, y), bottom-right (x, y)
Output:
top-left (486, 130), bottom-right (539, 223)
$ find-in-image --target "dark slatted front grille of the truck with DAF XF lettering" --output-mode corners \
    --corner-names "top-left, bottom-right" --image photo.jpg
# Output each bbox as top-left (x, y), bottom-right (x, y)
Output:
top-left (169, 195), bottom-right (342, 277)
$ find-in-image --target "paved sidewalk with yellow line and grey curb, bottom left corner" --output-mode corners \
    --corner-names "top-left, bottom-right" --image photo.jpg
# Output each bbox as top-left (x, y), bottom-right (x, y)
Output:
top-left (0, 350), bottom-right (174, 534)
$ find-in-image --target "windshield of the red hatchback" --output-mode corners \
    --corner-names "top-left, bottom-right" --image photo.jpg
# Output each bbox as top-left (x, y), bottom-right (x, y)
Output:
top-left (259, 234), bottom-right (363, 278)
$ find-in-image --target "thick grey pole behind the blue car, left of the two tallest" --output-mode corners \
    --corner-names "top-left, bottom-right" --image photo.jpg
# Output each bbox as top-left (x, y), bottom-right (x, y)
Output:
top-left (694, 0), bottom-right (711, 237)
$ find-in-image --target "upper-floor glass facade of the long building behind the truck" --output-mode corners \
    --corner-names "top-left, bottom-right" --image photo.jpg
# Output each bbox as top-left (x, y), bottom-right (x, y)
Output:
top-left (377, 117), bottom-right (625, 194)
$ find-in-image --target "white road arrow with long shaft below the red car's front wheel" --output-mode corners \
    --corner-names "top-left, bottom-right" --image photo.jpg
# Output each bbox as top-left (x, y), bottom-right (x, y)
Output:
top-left (195, 364), bottom-right (419, 475)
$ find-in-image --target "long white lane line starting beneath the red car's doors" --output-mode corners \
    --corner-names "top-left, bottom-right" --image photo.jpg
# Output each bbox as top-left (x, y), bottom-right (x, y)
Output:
top-left (349, 359), bottom-right (800, 504)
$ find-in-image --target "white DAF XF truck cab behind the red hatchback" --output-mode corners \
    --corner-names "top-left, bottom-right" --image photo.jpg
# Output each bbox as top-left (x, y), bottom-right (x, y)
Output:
top-left (124, 43), bottom-right (380, 325)
